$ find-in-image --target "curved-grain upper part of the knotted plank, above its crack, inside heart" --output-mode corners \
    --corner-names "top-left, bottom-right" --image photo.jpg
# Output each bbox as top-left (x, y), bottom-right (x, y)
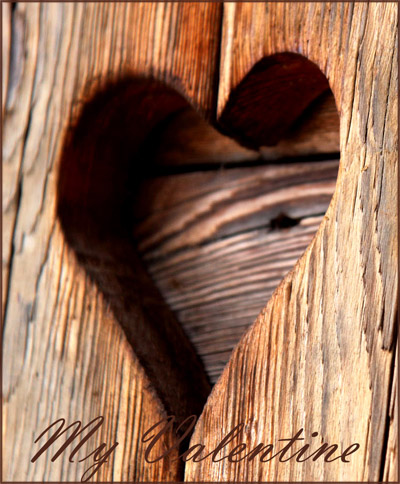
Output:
top-left (134, 160), bottom-right (338, 257)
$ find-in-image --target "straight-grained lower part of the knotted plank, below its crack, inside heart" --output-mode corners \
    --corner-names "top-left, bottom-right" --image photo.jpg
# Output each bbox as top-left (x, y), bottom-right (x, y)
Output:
top-left (142, 217), bottom-right (322, 383)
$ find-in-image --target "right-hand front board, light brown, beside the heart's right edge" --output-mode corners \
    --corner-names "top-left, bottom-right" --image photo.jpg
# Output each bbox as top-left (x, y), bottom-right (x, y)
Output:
top-left (185, 3), bottom-right (397, 481)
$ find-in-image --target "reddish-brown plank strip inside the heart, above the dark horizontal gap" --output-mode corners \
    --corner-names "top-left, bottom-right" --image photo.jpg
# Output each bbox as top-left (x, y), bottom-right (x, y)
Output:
top-left (148, 93), bottom-right (340, 167)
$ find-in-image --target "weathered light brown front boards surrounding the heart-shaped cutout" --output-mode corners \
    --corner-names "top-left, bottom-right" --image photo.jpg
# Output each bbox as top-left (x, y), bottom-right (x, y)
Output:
top-left (2, 3), bottom-right (397, 481)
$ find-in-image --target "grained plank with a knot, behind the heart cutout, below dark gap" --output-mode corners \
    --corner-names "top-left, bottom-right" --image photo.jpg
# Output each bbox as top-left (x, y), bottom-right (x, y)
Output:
top-left (135, 161), bottom-right (338, 383)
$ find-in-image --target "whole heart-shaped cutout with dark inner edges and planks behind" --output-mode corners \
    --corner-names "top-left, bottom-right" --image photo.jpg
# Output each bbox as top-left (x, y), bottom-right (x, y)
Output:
top-left (58, 53), bottom-right (339, 430)
